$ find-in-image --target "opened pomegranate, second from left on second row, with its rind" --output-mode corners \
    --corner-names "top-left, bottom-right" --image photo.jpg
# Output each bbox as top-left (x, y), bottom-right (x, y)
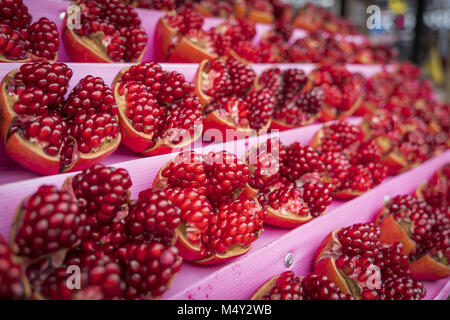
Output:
top-left (113, 62), bottom-right (203, 156)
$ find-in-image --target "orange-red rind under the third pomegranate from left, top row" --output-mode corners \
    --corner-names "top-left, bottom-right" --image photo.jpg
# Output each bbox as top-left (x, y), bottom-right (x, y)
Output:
top-left (168, 37), bottom-right (217, 63)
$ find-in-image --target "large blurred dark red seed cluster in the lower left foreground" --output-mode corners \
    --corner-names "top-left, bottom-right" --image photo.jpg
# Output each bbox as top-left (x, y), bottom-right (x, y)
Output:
top-left (4, 165), bottom-right (182, 299)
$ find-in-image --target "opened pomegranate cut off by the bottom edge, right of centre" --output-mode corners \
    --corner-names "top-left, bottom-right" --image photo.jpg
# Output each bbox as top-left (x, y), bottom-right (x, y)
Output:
top-left (250, 271), bottom-right (353, 300)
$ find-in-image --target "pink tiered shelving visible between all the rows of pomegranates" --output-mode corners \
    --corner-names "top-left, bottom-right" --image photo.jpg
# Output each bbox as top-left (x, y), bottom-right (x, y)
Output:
top-left (0, 0), bottom-right (450, 299)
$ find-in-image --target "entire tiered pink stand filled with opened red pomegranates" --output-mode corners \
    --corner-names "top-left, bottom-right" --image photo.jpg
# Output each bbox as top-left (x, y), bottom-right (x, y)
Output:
top-left (0, 0), bottom-right (450, 301)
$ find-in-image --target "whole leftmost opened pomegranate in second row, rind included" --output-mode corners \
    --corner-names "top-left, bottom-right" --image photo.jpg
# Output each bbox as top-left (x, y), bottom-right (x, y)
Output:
top-left (0, 62), bottom-right (121, 175)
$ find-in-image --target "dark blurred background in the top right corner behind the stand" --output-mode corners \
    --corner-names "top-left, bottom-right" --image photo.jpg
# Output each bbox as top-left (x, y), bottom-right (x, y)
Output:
top-left (285, 0), bottom-right (450, 100)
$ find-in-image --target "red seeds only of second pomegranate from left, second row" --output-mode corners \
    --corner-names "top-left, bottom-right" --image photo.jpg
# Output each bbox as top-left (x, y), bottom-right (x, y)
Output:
top-left (116, 62), bottom-right (203, 149)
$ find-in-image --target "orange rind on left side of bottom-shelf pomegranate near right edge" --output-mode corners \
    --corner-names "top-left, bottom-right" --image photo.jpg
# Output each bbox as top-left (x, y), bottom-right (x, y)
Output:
top-left (374, 208), bottom-right (417, 255)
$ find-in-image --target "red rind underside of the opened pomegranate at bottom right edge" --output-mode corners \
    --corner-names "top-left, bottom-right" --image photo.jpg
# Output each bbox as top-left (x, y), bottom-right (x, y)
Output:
top-left (409, 255), bottom-right (450, 281)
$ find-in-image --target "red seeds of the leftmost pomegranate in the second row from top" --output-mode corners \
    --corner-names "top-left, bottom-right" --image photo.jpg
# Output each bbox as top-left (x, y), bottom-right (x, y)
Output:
top-left (5, 62), bottom-right (119, 170)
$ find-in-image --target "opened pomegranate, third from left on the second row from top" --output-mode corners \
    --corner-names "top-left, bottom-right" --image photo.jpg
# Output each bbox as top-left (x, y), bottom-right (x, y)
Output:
top-left (197, 58), bottom-right (275, 141)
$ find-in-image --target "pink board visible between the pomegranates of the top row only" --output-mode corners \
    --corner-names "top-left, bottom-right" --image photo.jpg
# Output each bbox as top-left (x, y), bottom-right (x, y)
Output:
top-left (24, 0), bottom-right (367, 62)
